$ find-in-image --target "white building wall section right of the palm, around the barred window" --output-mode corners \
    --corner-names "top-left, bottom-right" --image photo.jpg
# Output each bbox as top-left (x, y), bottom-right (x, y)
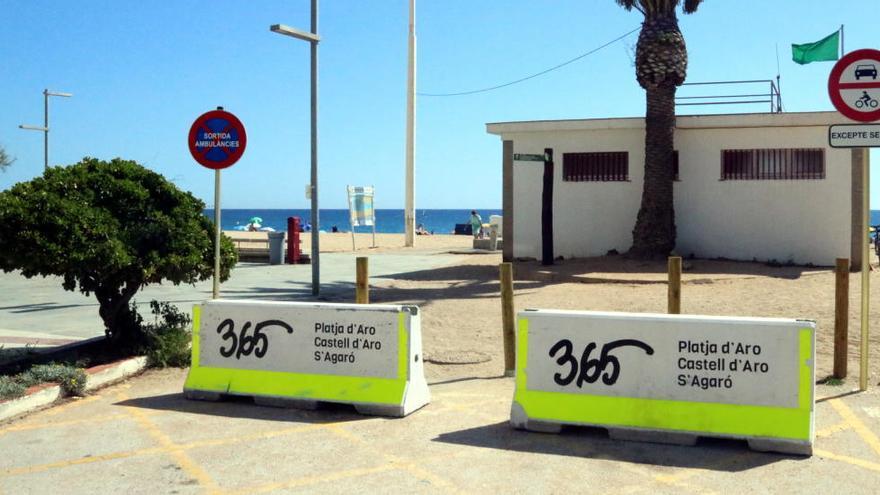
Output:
top-left (675, 127), bottom-right (852, 265)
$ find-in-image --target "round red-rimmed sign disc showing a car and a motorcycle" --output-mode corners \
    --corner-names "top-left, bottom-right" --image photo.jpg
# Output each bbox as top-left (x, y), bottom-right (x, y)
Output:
top-left (828, 49), bottom-right (880, 122)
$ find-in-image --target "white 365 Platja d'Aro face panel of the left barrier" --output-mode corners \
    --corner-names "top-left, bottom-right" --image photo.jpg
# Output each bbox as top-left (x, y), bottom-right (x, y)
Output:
top-left (198, 301), bottom-right (400, 378)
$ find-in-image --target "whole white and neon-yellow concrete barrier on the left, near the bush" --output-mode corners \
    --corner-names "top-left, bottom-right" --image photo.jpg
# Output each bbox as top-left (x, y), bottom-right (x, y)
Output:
top-left (184, 300), bottom-right (430, 417)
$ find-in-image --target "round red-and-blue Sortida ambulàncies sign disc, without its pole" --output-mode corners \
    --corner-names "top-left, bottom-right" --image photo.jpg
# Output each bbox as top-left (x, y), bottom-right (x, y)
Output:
top-left (187, 109), bottom-right (247, 170)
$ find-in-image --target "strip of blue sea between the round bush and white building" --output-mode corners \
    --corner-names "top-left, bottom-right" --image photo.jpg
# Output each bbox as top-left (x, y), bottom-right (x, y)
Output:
top-left (205, 208), bottom-right (501, 234)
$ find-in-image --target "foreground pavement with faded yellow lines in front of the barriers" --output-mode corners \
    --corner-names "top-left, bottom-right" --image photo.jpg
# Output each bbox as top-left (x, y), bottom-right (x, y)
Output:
top-left (0, 370), bottom-right (880, 495)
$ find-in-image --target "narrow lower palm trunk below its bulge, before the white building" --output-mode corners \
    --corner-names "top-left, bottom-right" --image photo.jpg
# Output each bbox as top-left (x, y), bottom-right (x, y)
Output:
top-left (630, 81), bottom-right (676, 258)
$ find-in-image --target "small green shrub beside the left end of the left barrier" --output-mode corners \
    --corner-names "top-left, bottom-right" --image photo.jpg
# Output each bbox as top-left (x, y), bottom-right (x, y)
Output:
top-left (144, 301), bottom-right (192, 368)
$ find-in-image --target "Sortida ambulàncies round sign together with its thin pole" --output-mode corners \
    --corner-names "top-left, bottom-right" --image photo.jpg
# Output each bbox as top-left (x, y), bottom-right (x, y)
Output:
top-left (187, 107), bottom-right (247, 299)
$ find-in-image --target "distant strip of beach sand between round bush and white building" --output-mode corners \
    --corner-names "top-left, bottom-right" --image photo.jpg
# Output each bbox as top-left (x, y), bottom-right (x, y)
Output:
top-left (223, 230), bottom-right (473, 253)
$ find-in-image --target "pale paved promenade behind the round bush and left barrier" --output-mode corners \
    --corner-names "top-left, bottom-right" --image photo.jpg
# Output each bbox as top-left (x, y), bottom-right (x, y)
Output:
top-left (0, 251), bottom-right (456, 348)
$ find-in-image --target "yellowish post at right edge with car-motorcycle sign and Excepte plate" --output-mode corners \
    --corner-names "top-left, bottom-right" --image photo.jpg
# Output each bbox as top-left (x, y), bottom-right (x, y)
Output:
top-left (828, 49), bottom-right (880, 391)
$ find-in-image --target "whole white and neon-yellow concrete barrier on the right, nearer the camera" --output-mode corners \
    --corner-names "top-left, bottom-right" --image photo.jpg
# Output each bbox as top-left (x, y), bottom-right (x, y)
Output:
top-left (510, 310), bottom-right (816, 455)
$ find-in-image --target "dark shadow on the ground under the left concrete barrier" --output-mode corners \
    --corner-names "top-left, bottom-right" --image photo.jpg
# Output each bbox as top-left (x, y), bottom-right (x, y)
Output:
top-left (113, 393), bottom-right (370, 424)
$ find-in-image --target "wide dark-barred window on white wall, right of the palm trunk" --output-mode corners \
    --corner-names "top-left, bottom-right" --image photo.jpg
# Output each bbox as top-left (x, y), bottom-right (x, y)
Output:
top-left (721, 148), bottom-right (825, 180)
